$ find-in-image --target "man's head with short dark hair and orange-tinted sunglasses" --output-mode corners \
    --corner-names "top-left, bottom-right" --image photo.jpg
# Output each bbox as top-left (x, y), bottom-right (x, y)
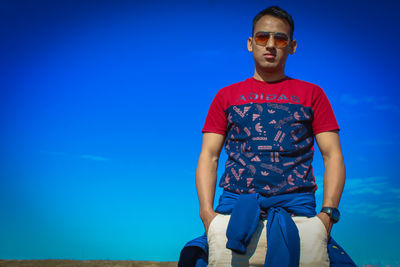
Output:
top-left (247, 6), bottom-right (297, 74)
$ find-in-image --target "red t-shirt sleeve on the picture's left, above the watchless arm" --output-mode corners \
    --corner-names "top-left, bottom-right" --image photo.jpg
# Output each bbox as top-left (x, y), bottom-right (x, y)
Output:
top-left (201, 90), bottom-right (227, 135)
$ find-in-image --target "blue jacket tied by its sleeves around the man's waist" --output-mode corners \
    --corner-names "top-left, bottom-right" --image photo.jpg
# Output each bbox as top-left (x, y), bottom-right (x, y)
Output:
top-left (179, 190), bottom-right (356, 267)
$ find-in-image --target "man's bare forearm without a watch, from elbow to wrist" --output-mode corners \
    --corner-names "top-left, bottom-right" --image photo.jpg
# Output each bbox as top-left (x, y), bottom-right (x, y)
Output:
top-left (196, 155), bottom-right (218, 216)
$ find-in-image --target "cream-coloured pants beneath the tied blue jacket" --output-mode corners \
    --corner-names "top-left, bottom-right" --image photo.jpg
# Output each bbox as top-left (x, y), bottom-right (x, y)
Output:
top-left (207, 214), bottom-right (329, 267)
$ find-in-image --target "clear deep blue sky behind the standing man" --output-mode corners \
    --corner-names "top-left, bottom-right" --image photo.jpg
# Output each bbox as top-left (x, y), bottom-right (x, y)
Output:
top-left (0, 0), bottom-right (400, 266)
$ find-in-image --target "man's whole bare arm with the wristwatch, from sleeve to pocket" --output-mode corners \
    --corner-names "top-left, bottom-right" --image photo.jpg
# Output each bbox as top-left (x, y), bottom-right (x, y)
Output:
top-left (315, 131), bottom-right (346, 238)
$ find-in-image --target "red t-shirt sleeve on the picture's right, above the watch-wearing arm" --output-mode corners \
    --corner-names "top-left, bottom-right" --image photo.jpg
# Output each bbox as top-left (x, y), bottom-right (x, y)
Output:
top-left (312, 86), bottom-right (340, 135)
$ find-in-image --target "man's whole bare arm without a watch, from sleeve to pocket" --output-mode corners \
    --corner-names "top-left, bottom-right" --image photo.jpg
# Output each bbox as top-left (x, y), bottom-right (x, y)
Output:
top-left (196, 133), bottom-right (225, 232)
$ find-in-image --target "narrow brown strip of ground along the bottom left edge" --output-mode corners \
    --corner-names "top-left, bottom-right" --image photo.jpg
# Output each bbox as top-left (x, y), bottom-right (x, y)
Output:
top-left (0, 260), bottom-right (178, 267)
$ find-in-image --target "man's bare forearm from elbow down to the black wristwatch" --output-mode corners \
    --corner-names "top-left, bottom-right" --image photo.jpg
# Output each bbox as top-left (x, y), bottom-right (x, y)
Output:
top-left (322, 155), bottom-right (346, 208)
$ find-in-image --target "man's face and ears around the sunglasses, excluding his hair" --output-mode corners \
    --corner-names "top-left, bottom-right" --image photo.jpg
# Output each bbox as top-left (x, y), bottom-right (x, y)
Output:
top-left (247, 15), bottom-right (297, 73)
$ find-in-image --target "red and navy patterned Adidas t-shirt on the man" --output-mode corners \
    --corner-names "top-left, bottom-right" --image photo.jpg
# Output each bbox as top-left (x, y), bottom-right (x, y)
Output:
top-left (202, 77), bottom-right (339, 196)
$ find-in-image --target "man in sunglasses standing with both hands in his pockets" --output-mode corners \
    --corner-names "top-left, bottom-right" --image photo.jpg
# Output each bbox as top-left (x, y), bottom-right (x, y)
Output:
top-left (179, 6), bottom-right (355, 266)
